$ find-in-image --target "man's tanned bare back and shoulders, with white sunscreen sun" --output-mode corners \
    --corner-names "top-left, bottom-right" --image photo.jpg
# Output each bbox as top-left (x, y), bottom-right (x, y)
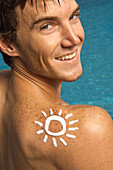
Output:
top-left (0, 71), bottom-right (113, 170)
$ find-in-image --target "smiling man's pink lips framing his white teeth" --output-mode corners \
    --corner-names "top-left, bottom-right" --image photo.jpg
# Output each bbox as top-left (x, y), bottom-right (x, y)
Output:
top-left (55, 48), bottom-right (79, 63)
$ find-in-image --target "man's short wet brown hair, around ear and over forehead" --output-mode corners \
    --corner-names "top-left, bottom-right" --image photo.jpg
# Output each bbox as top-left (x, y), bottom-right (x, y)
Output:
top-left (0, 0), bottom-right (60, 66)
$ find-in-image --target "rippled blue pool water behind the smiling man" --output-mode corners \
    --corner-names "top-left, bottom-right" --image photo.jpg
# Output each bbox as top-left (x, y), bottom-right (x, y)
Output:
top-left (0, 0), bottom-right (113, 118)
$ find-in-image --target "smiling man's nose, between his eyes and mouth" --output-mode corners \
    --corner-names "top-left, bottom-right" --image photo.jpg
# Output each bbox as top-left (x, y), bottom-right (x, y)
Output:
top-left (61, 25), bottom-right (80, 48)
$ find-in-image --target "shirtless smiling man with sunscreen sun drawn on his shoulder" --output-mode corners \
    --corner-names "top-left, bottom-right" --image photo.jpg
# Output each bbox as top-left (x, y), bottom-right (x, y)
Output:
top-left (0, 0), bottom-right (113, 170)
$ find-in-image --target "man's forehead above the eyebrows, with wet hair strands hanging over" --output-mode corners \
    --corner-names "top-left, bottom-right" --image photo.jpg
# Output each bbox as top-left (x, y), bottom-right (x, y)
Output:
top-left (17, 0), bottom-right (77, 24)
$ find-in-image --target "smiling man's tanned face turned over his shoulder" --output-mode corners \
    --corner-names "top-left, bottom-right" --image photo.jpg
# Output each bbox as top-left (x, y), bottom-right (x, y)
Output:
top-left (16, 0), bottom-right (84, 81)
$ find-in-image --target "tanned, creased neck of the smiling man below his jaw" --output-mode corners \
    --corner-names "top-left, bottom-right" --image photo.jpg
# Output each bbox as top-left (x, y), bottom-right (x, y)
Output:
top-left (9, 65), bottom-right (63, 103)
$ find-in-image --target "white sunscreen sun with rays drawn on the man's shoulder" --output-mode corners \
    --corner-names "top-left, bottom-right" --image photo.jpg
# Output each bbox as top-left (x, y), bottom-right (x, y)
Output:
top-left (35, 109), bottom-right (79, 147)
